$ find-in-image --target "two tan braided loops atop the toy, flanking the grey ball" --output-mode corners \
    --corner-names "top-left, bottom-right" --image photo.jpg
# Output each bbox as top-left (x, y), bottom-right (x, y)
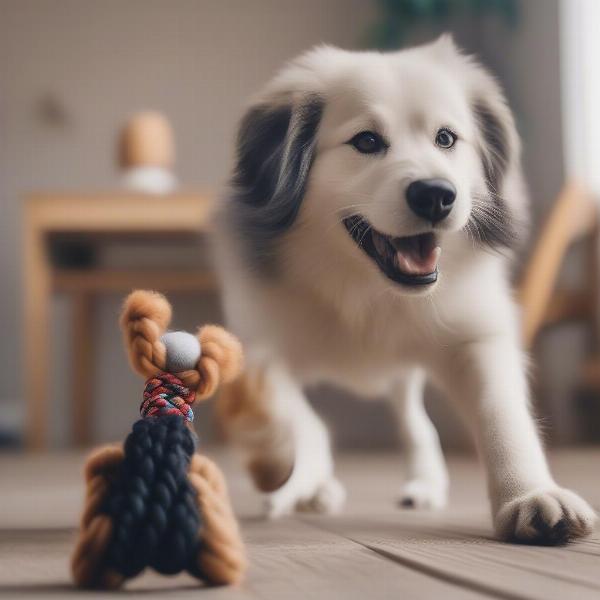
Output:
top-left (120, 290), bottom-right (243, 400)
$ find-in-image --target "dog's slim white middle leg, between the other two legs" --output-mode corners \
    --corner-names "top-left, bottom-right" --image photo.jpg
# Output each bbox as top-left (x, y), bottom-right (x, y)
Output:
top-left (390, 369), bottom-right (448, 509)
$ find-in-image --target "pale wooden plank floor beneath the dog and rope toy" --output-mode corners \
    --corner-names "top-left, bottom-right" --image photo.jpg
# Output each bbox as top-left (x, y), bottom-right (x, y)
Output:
top-left (0, 450), bottom-right (600, 600)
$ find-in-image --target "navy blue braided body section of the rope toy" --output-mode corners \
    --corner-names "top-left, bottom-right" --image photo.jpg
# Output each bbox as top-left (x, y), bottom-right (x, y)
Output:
top-left (102, 415), bottom-right (202, 578)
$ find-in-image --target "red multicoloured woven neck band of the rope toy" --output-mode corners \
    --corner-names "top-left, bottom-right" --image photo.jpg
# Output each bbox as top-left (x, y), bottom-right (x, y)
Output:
top-left (140, 372), bottom-right (196, 421)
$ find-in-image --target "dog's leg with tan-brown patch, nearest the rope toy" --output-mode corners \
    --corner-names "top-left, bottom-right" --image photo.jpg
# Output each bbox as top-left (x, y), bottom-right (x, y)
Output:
top-left (217, 364), bottom-right (346, 517)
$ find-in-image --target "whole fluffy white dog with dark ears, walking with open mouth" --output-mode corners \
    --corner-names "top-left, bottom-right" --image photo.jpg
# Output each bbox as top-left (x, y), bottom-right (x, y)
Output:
top-left (217, 36), bottom-right (595, 544)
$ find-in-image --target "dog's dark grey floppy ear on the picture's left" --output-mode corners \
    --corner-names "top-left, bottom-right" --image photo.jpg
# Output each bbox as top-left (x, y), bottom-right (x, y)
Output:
top-left (232, 96), bottom-right (323, 266)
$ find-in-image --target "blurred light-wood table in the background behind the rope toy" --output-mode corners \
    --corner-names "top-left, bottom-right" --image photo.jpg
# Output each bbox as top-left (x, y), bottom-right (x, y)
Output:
top-left (23, 193), bottom-right (216, 449)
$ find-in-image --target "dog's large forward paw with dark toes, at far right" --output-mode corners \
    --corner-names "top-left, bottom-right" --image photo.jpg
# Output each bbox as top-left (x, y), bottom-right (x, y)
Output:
top-left (494, 487), bottom-right (597, 546)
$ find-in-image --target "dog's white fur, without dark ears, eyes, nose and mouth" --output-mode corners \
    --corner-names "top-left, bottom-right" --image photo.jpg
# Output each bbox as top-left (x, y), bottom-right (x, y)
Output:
top-left (212, 37), bottom-right (595, 540)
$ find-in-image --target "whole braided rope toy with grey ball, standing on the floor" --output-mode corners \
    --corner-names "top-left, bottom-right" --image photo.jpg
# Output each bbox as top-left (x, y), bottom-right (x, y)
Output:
top-left (71, 290), bottom-right (246, 589)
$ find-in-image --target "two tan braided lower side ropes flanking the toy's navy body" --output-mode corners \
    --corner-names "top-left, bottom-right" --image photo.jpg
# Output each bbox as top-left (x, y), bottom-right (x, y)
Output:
top-left (71, 446), bottom-right (247, 589)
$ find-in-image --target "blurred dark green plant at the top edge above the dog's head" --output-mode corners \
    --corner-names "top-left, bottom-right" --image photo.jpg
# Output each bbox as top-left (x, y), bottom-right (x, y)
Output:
top-left (369, 0), bottom-right (518, 49)
